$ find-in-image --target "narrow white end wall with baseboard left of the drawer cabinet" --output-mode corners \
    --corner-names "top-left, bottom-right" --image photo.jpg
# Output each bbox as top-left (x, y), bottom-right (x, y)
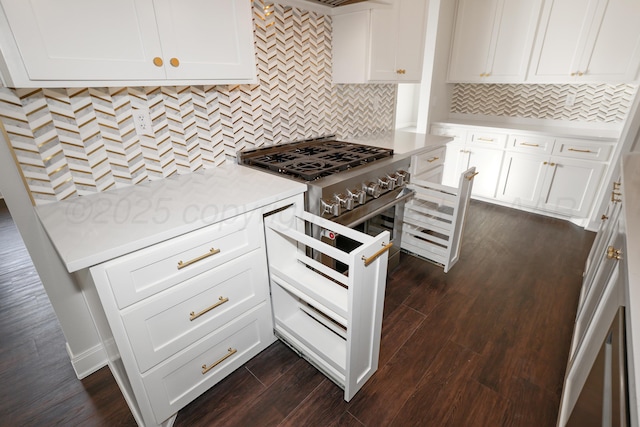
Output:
top-left (0, 125), bottom-right (107, 378)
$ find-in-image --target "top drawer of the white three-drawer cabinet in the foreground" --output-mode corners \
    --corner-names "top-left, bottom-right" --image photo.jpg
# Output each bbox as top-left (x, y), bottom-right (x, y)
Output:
top-left (106, 215), bottom-right (262, 309)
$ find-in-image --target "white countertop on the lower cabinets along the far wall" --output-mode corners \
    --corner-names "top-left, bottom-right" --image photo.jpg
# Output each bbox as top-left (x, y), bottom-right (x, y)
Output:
top-left (433, 119), bottom-right (620, 142)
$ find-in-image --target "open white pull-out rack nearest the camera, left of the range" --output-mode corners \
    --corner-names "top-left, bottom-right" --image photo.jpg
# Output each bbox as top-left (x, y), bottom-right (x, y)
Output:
top-left (265, 204), bottom-right (391, 401)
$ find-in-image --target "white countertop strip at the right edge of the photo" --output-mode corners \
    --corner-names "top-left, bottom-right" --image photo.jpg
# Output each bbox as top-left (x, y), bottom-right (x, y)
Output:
top-left (621, 153), bottom-right (640, 422)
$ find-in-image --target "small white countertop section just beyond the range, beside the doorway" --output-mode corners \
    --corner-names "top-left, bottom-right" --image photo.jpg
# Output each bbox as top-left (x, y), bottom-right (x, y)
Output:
top-left (346, 130), bottom-right (452, 156)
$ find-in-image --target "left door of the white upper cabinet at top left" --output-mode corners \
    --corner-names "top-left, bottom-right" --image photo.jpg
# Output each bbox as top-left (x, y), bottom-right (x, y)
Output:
top-left (0, 0), bottom-right (165, 80)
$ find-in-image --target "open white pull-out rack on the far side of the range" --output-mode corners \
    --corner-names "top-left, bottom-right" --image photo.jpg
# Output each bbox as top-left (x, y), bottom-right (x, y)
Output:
top-left (401, 167), bottom-right (478, 273)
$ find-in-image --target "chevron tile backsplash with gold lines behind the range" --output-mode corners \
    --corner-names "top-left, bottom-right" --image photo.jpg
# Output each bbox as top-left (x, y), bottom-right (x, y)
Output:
top-left (0, 0), bottom-right (396, 204)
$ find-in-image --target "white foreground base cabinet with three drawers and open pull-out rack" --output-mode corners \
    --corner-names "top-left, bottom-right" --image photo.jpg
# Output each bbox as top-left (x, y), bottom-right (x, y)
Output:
top-left (85, 195), bottom-right (390, 426)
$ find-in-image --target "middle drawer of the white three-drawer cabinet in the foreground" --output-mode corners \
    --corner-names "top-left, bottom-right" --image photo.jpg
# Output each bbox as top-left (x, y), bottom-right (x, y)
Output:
top-left (121, 250), bottom-right (268, 372)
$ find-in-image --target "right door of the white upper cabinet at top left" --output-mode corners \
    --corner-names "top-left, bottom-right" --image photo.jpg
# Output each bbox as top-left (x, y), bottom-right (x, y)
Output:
top-left (154, 0), bottom-right (255, 80)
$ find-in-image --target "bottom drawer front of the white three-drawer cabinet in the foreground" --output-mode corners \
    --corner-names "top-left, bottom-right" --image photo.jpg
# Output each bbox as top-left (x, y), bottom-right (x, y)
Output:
top-left (142, 302), bottom-right (275, 423)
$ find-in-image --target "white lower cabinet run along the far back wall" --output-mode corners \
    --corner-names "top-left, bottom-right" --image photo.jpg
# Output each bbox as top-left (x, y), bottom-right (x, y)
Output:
top-left (431, 124), bottom-right (615, 219)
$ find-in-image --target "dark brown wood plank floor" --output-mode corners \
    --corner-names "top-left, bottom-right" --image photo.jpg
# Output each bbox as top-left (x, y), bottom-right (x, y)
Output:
top-left (0, 201), bottom-right (594, 427)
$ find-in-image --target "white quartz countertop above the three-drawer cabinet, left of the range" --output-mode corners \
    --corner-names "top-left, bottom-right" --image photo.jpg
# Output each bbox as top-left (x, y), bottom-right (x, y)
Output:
top-left (36, 164), bottom-right (307, 272)
